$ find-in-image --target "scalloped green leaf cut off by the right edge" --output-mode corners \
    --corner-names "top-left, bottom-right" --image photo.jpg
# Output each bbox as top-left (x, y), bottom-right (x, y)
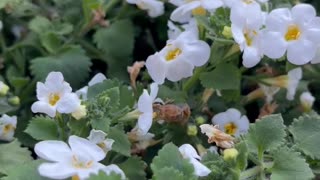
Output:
top-left (289, 114), bottom-right (320, 159)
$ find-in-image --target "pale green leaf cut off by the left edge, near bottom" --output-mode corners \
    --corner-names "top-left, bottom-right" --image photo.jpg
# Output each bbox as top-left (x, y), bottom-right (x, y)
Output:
top-left (0, 140), bottom-right (32, 174)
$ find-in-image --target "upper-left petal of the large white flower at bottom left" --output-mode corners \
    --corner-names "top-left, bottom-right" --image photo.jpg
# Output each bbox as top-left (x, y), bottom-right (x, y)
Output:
top-left (34, 141), bottom-right (72, 162)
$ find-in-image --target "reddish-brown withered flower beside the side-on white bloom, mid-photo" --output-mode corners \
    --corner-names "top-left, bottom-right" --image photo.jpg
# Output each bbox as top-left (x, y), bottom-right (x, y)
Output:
top-left (153, 104), bottom-right (191, 124)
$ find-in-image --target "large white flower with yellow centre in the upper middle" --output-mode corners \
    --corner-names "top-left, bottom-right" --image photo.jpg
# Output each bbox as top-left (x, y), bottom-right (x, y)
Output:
top-left (146, 31), bottom-right (210, 84)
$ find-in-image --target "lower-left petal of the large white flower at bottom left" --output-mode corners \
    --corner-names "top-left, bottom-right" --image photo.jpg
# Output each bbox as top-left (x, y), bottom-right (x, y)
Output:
top-left (38, 163), bottom-right (76, 179)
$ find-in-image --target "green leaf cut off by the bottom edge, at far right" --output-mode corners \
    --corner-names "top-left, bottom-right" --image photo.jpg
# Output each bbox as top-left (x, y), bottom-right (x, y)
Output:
top-left (271, 148), bottom-right (314, 180)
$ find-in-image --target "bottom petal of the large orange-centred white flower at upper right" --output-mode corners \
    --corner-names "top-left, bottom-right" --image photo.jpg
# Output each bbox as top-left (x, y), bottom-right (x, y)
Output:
top-left (287, 40), bottom-right (317, 65)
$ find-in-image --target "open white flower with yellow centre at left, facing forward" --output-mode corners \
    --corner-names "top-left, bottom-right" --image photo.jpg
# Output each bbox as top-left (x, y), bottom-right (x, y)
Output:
top-left (31, 72), bottom-right (80, 117)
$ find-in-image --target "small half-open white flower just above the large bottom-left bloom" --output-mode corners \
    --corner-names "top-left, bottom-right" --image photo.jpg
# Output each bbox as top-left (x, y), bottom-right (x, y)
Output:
top-left (88, 129), bottom-right (114, 153)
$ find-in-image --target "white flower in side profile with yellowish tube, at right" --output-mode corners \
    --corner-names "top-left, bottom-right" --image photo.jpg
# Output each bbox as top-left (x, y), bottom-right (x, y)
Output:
top-left (262, 67), bottom-right (302, 100)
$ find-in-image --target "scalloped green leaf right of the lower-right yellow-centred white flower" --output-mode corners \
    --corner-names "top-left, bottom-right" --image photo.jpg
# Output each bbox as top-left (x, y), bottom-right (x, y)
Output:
top-left (246, 114), bottom-right (286, 153)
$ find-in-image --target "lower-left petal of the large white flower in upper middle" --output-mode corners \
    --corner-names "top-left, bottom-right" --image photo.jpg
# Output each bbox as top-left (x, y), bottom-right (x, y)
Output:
top-left (146, 53), bottom-right (167, 84)
